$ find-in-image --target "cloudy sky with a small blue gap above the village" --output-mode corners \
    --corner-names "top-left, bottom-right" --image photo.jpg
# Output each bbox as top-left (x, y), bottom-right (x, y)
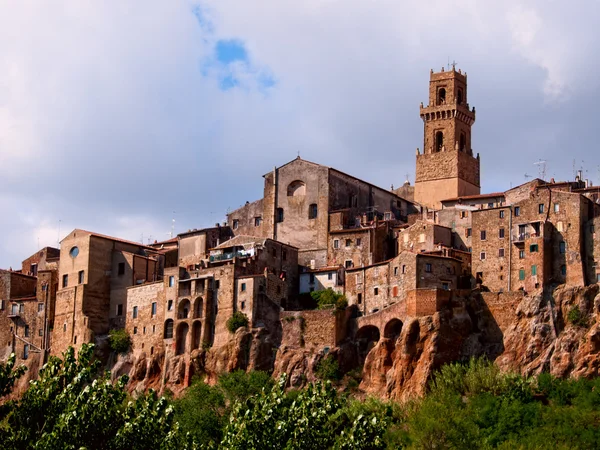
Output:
top-left (0, 0), bottom-right (600, 268)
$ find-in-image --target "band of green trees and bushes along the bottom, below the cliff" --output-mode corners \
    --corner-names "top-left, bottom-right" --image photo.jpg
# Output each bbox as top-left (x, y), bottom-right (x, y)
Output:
top-left (0, 352), bottom-right (600, 450)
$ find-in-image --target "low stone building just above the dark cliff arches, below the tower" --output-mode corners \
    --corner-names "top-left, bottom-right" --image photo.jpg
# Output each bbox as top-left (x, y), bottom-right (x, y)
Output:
top-left (345, 251), bottom-right (462, 314)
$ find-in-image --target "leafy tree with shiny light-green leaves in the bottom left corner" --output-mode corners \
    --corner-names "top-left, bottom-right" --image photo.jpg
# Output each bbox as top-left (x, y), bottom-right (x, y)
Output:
top-left (0, 345), bottom-right (178, 449)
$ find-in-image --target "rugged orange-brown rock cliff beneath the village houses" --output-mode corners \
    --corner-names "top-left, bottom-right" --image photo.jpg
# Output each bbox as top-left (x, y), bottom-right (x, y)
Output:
top-left (113, 285), bottom-right (600, 401)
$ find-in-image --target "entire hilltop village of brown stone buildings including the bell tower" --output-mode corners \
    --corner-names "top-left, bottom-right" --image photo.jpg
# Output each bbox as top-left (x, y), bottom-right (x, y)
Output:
top-left (0, 68), bottom-right (600, 386)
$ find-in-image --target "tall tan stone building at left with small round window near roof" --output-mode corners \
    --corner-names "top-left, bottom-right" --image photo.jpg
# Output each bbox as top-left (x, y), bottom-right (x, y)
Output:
top-left (52, 229), bottom-right (164, 354)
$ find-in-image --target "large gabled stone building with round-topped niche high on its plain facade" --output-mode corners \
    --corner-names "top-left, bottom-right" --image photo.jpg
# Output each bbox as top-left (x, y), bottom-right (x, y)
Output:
top-left (227, 157), bottom-right (415, 268)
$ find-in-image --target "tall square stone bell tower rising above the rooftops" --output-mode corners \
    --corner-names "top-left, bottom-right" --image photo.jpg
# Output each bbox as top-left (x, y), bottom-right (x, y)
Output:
top-left (415, 67), bottom-right (480, 209)
